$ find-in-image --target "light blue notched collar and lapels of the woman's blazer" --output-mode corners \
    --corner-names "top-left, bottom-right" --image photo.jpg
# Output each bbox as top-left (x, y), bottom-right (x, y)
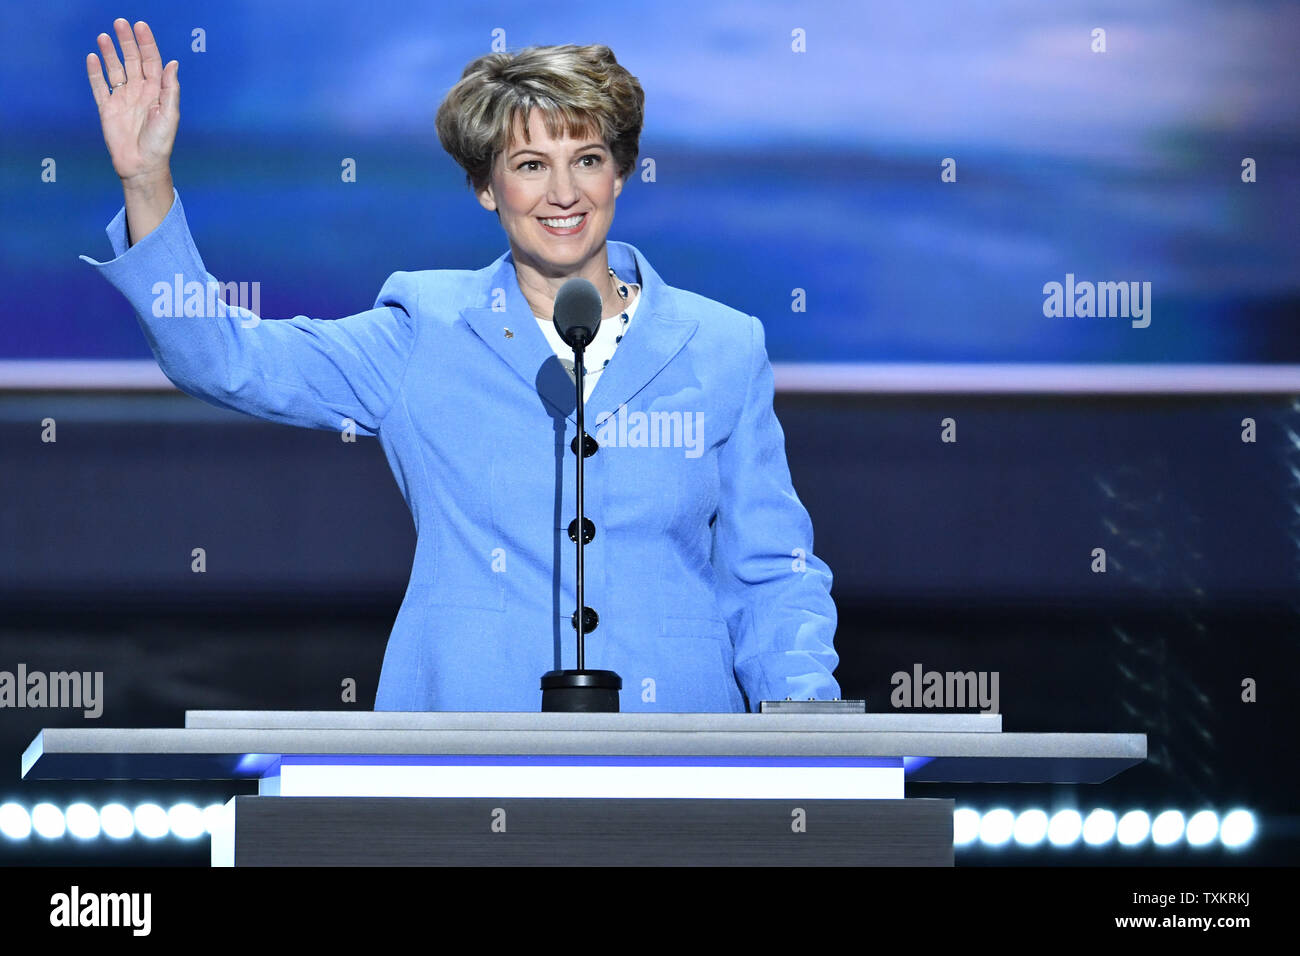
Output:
top-left (460, 241), bottom-right (699, 431)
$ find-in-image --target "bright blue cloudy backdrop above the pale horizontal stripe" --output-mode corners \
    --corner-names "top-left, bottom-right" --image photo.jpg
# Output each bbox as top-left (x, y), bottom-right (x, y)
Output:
top-left (0, 0), bottom-right (1300, 363)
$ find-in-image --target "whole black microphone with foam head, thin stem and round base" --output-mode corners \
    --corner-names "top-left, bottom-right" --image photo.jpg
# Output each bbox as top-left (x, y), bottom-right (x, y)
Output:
top-left (542, 278), bottom-right (623, 714)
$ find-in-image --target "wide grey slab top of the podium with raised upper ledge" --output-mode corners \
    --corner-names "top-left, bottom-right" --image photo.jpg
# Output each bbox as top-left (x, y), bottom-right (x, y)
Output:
top-left (22, 710), bottom-right (1147, 783)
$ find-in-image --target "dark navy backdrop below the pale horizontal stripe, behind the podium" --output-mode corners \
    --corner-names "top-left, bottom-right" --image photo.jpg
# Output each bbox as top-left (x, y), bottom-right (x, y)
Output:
top-left (0, 393), bottom-right (1300, 865)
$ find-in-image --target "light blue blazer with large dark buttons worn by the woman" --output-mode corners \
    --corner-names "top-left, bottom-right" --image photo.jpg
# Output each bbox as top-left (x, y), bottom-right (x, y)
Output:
top-left (82, 188), bottom-right (840, 711)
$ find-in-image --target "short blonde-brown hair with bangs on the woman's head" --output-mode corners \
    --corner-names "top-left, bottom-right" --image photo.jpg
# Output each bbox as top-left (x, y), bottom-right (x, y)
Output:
top-left (434, 43), bottom-right (645, 193)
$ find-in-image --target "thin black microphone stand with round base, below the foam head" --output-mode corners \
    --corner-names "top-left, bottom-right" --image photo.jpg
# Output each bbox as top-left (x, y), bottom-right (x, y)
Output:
top-left (542, 330), bottom-right (623, 714)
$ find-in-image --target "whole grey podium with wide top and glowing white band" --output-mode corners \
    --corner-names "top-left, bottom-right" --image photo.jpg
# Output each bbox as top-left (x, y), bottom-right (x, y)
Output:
top-left (22, 710), bottom-right (1147, 866)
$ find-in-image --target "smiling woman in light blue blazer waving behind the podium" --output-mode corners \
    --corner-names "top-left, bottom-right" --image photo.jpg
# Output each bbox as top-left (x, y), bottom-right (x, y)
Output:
top-left (82, 20), bottom-right (840, 711)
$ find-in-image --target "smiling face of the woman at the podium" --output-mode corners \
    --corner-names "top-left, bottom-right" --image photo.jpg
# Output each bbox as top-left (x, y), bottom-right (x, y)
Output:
top-left (478, 109), bottom-right (623, 277)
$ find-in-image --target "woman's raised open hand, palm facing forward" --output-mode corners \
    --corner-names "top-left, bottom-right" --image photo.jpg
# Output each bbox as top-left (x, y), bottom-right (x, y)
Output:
top-left (86, 18), bottom-right (181, 185)
